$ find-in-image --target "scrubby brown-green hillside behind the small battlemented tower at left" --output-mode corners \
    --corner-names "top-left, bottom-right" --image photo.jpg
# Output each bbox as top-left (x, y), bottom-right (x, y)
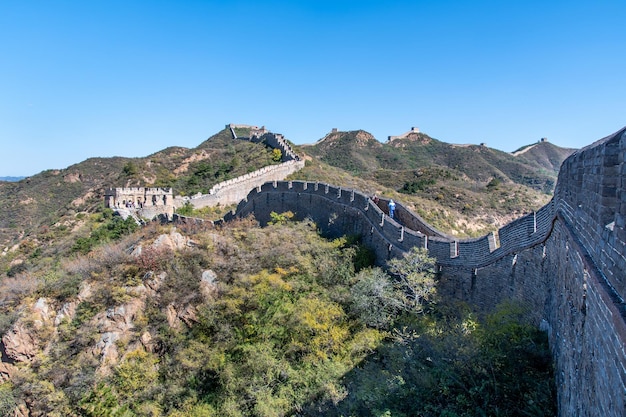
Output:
top-left (0, 129), bottom-right (277, 247)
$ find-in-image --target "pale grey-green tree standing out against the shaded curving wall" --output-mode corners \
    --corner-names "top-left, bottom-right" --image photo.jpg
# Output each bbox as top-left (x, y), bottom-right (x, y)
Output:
top-left (388, 247), bottom-right (436, 312)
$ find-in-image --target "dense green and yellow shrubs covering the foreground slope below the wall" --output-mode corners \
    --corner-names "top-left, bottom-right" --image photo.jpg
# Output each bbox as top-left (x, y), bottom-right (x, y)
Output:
top-left (0, 213), bottom-right (555, 416)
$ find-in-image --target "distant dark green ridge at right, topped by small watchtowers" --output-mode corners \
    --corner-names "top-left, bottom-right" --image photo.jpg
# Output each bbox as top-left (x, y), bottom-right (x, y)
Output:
top-left (304, 130), bottom-right (573, 193)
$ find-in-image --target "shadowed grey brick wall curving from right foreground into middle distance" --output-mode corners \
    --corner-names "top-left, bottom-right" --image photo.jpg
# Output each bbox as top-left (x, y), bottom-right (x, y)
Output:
top-left (107, 125), bottom-right (626, 416)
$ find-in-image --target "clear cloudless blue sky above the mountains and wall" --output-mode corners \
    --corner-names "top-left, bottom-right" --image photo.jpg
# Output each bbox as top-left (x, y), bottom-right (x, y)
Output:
top-left (0, 0), bottom-right (626, 176)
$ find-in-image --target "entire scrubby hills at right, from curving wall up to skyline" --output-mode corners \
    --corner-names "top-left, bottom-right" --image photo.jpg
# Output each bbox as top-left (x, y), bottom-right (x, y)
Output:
top-left (292, 130), bottom-right (573, 236)
